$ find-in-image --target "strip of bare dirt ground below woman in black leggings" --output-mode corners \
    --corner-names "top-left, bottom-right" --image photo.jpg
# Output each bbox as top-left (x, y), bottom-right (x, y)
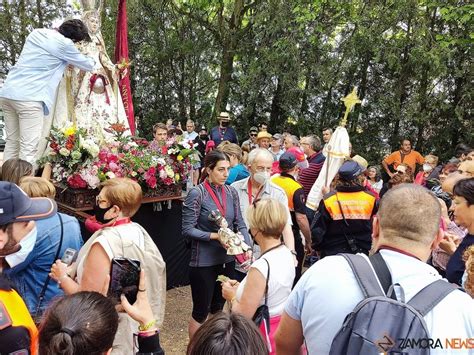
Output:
top-left (160, 286), bottom-right (192, 355)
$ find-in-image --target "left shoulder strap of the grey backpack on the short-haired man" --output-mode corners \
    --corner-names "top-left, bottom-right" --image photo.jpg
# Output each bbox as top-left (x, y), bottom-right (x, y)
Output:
top-left (338, 254), bottom-right (385, 298)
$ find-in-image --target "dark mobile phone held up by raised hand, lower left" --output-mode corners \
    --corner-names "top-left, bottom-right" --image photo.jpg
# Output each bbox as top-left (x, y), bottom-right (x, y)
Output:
top-left (107, 258), bottom-right (140, 304)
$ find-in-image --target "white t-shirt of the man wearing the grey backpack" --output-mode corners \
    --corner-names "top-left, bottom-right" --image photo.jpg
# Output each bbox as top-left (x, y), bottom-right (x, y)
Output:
top-left (285, 249), bottom-right (474, 355)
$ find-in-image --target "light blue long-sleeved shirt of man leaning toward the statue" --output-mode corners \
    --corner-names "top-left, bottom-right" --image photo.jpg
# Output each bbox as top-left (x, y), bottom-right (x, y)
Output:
top-left (0, 28), bottom-right (95, 115)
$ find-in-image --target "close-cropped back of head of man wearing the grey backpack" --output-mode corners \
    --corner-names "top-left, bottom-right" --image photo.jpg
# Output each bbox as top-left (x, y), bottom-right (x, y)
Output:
top-left (378, 184), bottom-right (441, 248)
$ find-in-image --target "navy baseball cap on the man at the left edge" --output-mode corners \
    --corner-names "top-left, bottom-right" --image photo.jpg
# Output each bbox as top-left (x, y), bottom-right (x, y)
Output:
top-left (0, 181), bottom-right (57, 225)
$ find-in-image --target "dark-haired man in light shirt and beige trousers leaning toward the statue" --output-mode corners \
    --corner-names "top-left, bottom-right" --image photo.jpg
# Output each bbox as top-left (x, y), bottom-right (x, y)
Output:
top-left (0, 20), bottom-right (95, 164)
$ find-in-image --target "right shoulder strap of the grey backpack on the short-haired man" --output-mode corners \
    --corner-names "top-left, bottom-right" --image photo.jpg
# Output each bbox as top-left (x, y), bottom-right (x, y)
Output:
top-left (408, 279), bottom-right (459, 317)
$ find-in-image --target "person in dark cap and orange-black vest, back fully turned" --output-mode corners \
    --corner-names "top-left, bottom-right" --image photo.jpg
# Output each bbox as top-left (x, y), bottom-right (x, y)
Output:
top-left (311, 160), bottom-right (377, 257)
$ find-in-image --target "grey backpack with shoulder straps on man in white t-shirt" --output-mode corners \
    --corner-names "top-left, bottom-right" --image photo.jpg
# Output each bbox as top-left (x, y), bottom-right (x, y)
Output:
top-left (329, 253), bottom-right (458, 355)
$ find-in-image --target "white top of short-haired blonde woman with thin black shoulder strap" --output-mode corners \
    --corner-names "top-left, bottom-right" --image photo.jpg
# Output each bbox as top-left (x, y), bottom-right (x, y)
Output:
top-left (236, 245), bottom-right (295, 317)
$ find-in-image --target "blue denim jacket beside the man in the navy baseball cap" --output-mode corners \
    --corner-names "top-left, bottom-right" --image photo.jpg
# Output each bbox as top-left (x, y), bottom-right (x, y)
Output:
top-left (4, 213), bottom-right (83, 317)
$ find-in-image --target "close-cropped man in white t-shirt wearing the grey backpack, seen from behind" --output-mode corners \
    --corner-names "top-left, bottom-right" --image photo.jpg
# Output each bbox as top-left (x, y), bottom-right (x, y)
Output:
top-left (276, 184), bottom-right (474, 355)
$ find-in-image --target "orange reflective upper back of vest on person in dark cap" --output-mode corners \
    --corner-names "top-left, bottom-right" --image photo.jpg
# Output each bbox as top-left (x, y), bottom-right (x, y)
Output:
top-left (324, 191), bottom-right (376, 221)
